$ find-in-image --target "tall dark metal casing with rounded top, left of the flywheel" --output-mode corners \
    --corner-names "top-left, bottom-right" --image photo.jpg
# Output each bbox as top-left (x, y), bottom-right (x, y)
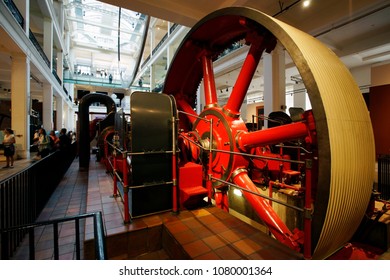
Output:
top-left (129, 92), bottom-right (176, 217)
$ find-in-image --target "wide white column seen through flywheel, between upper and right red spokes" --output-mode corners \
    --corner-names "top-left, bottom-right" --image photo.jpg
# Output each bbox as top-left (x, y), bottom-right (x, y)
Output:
top-left (263, 46), bottom-right (286, 126)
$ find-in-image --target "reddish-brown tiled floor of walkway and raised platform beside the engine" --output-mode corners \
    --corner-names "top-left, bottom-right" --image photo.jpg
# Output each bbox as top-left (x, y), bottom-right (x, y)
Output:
top-left (7, 155), bottom-right (390, 260)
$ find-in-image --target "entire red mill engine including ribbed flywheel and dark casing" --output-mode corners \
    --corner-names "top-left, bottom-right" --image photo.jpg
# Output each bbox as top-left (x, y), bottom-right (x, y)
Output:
top-left (80, 7), bottom-right (386, 259)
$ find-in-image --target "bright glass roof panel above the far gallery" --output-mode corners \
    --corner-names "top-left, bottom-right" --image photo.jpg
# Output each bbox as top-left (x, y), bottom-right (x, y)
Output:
top-left (64, 0), bottom-right (148, 87)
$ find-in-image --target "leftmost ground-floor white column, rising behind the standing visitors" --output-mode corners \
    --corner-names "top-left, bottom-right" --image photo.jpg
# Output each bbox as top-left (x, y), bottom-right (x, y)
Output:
top-left (11, 55), bottom-right (31, 158)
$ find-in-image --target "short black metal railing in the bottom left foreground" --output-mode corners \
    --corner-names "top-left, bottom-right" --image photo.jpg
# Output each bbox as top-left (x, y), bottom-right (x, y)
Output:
top-left (0, 211), bottom-right (107, 260)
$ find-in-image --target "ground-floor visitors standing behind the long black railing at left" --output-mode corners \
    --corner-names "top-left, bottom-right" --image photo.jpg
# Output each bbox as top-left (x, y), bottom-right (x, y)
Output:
top-left (2, 128), bottom-right (76, 168)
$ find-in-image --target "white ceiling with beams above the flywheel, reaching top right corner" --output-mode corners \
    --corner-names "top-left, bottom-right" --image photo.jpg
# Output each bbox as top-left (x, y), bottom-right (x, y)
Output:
top-left (103, 0), bottom-right (390, 76)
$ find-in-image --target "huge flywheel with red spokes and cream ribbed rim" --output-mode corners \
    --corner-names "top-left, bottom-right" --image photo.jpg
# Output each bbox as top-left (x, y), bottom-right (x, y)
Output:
top-left (163, 7), bottom-right (375, 259)
